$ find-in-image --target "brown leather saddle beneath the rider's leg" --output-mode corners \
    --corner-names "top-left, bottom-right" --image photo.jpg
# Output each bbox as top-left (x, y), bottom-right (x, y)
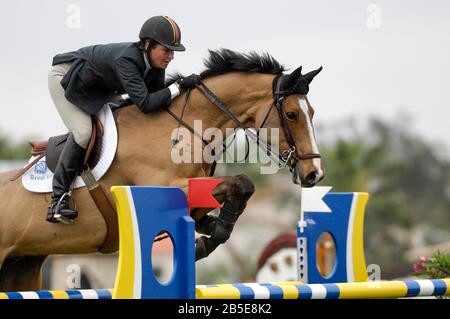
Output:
top-left (10, 116), bottom-right (104, 181)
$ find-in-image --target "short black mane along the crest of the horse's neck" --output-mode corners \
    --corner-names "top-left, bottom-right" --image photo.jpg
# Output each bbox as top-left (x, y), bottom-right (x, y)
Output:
top-left (166, 49), bottom-right (286, 85)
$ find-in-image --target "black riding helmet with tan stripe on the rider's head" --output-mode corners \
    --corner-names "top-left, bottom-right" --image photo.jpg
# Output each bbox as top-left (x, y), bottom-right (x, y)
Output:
top-left (139, 16), bottom-right (186, 51)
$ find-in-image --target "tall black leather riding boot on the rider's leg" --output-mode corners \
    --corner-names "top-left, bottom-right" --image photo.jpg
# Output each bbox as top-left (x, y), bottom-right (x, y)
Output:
top-left (47, 134), bottom-right (85, 224)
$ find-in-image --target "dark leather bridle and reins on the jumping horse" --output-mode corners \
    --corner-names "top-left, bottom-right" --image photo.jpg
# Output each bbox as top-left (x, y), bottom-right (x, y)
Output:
top-left (167, 75), bottom-right (321, 176)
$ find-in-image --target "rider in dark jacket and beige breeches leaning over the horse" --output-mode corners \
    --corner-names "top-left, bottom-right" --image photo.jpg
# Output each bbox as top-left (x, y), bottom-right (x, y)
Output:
top-left (47, 16), bottom-right (200, 223)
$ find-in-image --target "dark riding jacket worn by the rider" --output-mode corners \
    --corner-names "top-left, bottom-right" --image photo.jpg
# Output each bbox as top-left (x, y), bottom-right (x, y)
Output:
top-left (52, 42), bottom-right (171, 114)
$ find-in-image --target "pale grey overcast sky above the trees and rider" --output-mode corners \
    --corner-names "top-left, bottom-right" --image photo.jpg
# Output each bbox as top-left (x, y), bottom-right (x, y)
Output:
top-left (0, 0), bottom-right (450, 157)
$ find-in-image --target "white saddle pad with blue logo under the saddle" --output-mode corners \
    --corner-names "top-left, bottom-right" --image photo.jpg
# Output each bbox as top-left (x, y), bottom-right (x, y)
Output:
top-left (22, 104), bottom-right (117, 193)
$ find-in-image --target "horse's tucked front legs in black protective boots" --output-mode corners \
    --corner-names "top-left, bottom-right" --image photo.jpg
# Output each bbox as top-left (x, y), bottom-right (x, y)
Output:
top-left (191, 175), bottom-right (255, 260)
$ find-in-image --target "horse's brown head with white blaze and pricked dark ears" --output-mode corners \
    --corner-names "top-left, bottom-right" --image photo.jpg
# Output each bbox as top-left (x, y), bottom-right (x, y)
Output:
top-left (255, 67), bottom-right (324, 187)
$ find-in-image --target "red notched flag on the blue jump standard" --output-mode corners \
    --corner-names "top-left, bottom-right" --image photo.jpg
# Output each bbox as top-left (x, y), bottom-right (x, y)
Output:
top-left (188, 178), bottom-right (222, 210)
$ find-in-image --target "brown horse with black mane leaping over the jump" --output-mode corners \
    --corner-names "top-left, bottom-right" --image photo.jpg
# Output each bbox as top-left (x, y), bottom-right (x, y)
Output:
top-left (0, 49), bottom-right (324, 291)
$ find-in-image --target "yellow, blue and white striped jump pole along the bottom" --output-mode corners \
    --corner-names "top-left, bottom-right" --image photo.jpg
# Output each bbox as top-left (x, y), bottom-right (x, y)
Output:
top-left (4, 278), bottom-right (450, 299)
